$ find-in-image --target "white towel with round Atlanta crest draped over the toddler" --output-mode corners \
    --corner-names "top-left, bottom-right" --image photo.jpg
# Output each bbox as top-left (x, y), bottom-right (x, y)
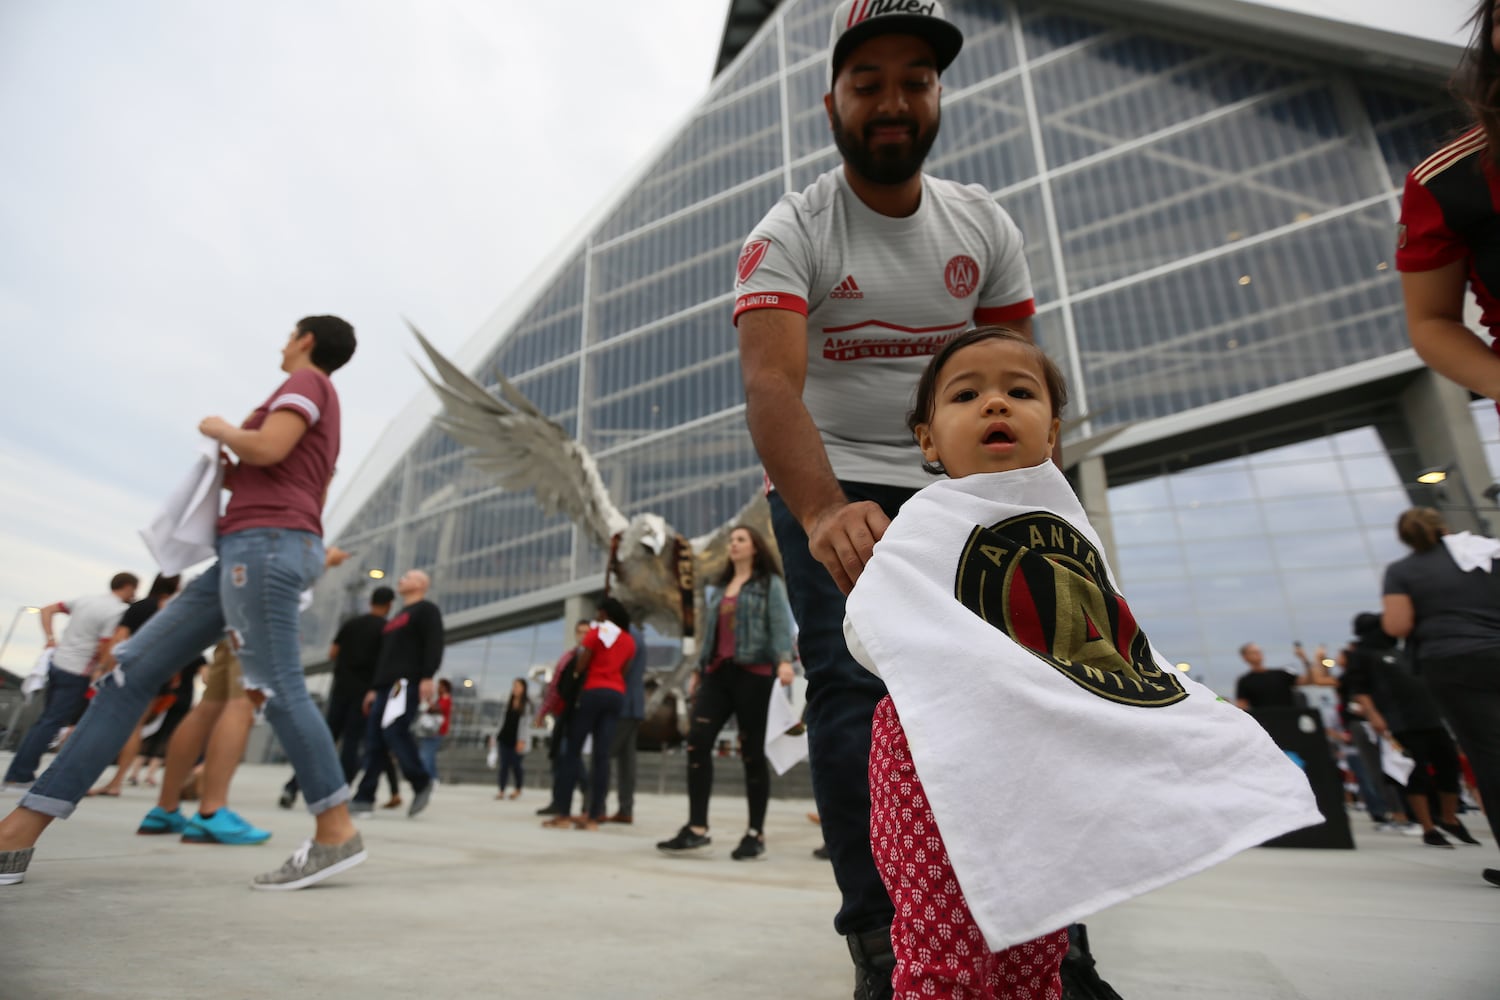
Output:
top-left (845, 462), bottom-right (1323, 951)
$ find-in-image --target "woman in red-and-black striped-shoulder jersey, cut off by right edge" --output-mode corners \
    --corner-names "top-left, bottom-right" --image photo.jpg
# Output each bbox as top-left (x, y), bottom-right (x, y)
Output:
top-left (1397, 0), bottom-right (1500, 413)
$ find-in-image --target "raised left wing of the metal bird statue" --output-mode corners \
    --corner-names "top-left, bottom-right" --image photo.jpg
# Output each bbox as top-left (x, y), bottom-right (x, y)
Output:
top-left (407, 321), bottom-right (629, 549)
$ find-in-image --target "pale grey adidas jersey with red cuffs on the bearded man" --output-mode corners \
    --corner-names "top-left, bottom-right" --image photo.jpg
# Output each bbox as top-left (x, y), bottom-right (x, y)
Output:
top-left (735, 166), bottom-right (1037, 487)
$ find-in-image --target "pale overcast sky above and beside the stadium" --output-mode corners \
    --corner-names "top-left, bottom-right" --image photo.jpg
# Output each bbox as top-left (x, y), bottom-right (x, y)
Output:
top-left (0, 0), bottom-right (1467, 680)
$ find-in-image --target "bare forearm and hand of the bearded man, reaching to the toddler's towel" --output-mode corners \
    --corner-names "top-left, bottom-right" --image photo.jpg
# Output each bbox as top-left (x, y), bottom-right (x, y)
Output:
top-left (740, 309), bottom-right (891, 594)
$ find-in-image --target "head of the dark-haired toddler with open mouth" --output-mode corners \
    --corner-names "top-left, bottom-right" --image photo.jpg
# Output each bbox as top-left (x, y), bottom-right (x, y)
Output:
top-left (917, 340), bottom-right (1061, 478)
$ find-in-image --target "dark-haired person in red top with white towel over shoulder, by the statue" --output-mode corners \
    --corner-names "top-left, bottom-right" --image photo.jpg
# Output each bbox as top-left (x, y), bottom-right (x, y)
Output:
top-left (543, 597), bottom-right (636, 831)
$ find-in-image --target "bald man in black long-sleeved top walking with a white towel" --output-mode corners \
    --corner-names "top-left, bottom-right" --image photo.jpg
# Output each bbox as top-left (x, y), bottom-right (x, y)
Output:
top-left (350, 570), bottom-right (443, 816)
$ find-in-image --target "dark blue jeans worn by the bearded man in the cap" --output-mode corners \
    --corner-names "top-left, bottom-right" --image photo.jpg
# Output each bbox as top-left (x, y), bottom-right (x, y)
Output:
top-left (771, 483), bottom-right (917, 934)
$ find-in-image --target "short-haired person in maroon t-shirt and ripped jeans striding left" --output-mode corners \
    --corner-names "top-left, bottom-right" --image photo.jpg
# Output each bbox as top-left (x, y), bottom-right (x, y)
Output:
top-left (0, 316), bottom-right (365, 889)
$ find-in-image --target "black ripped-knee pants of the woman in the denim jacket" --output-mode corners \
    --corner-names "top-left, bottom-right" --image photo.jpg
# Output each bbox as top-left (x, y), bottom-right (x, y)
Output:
top-left (687, 663), bottom-right (776, 832)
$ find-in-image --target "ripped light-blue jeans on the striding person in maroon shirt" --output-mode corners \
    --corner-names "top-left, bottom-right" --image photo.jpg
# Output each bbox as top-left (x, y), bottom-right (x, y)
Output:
top-left (21, 528), bottom-right (350, 819)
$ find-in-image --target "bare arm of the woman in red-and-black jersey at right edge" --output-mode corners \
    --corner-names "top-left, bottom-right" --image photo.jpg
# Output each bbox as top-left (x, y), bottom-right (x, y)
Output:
top-left (1401, 268), bottom-right (1500, 399)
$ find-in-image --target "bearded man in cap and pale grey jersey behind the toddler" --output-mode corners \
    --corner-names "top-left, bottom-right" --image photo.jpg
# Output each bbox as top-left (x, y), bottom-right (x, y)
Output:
top-left (735, 0), bottom-right (1115, 1000)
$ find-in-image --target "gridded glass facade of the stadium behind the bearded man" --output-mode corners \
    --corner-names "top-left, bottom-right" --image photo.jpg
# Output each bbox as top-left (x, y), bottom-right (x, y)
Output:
top-left (305, 0), bottom-right (1476, 707)
